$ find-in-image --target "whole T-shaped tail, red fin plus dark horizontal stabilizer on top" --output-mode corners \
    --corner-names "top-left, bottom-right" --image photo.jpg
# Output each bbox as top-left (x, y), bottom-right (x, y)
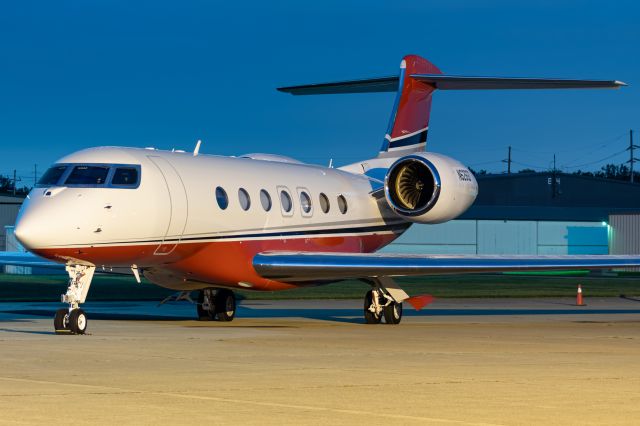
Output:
top-left (278, 55), bottom-right (625, 157)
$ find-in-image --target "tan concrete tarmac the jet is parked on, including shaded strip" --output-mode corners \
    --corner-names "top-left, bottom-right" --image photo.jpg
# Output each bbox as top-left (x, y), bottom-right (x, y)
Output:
top-left (0, 299), bottom-right (640, 425)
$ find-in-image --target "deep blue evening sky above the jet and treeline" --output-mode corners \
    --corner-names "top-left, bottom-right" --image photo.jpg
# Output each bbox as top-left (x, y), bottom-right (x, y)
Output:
top-left (0, 0), bottom-right (640, 182)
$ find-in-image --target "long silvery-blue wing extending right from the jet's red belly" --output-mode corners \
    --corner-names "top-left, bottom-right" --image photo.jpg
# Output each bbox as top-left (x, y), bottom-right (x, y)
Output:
top-left (253, 252), bottom-right (640, 282)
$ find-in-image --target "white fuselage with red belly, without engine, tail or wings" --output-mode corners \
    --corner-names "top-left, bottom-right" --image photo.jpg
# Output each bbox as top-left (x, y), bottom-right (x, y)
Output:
top-left (16, 147), bottom-right (420, 289)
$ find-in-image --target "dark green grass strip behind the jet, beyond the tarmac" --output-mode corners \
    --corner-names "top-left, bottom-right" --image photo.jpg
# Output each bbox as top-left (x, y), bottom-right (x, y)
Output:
top-left (0, 273), bottom-right (640, 302)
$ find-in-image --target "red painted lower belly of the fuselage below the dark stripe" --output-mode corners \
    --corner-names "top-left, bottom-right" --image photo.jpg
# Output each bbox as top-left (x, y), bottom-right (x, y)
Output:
top-left (32, 233), bottom-right (399, 290)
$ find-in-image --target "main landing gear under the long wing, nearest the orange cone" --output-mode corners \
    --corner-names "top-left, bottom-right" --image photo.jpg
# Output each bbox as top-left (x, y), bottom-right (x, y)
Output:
top-left (364, 277), bottom-right (409, 324)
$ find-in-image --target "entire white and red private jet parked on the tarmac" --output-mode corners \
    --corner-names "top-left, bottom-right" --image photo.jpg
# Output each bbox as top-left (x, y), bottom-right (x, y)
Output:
top-left (0, 55), bottom-right (640, 334)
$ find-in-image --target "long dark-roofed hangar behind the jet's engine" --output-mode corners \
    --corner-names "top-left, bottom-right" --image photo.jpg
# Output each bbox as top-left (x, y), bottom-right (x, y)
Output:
top-left (383, 172), bottom-right (640, 254)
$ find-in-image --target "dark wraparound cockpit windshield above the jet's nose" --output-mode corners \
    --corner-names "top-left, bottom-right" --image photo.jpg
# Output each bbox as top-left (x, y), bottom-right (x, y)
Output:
top-left (37, 164), bottom-right (140, 188)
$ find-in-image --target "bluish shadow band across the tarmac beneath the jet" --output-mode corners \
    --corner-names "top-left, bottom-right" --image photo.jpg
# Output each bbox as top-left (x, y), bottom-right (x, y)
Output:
top-left (0, 306), bottom-right (640, 324)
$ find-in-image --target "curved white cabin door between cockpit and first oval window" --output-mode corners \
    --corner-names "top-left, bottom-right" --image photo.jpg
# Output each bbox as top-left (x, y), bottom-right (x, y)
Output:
top-left (148, 155), bottom-right (189, 256)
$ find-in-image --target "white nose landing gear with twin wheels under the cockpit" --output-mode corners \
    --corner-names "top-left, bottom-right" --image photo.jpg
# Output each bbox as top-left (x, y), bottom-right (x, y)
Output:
top-left (53, 265), bottom-right (96, 334)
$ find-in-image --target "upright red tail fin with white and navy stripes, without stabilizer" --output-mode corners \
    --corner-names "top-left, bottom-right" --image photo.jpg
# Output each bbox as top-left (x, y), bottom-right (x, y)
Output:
top-left (380, 55), bottom-right (442, 156)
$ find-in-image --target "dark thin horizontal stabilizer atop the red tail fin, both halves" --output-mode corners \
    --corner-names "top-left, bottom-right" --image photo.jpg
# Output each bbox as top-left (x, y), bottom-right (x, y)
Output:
top-left (278, 74), bottom-right (626, 95)
